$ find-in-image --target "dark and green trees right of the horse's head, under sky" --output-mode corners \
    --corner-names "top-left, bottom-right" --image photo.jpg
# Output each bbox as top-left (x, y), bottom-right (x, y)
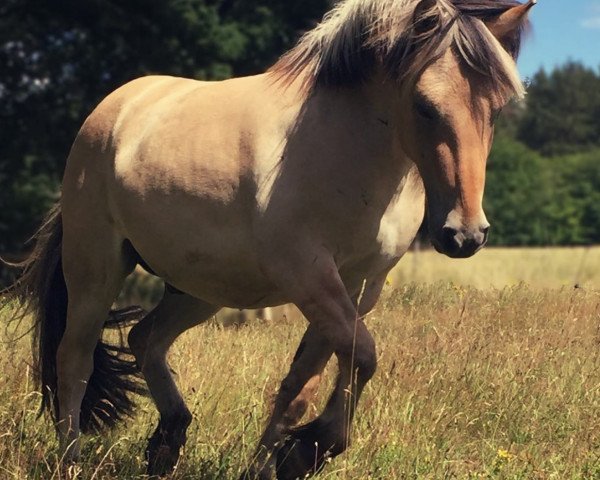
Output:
top-left (485, 62), bottom-right (600, 246)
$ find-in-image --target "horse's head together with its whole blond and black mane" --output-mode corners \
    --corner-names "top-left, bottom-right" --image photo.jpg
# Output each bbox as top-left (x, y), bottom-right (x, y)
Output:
top-left (271, 0), bottom-right (536, 257)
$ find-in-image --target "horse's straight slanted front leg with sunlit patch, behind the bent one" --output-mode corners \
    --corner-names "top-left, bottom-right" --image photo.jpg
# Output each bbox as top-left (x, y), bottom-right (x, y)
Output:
top-left (241, 325), bottom-right (333, 480)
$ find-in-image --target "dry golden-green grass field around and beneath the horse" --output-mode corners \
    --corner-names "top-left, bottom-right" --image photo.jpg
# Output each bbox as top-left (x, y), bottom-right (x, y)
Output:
top-left (0, 249), bottom-right (600, 480)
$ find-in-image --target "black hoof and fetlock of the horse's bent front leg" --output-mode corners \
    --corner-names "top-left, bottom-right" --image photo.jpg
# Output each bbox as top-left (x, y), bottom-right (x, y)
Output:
top-left (277, 420), bottom-right (344, 480)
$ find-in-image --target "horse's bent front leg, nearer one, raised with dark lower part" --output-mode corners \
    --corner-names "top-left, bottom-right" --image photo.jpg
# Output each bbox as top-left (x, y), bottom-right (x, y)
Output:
top-left (262, 251), bottom-right (377, 480)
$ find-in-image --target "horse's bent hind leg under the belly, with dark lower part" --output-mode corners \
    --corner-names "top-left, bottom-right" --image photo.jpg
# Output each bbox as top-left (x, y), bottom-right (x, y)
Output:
top-left (129, 291), bottom-right (219, 475)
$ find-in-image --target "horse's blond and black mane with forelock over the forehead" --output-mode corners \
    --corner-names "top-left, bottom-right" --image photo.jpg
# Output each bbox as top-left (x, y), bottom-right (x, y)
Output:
top-left (271, 0), bottom-right (524, 99)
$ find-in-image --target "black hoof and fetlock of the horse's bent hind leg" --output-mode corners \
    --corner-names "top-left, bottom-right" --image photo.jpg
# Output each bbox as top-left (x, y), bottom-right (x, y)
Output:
top-left (146, 416), bottom-right (191, 477)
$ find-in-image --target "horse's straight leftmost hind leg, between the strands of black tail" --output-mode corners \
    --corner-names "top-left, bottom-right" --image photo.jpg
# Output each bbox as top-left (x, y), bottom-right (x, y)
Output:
top-left (56, 227), bottom-right (133, 462)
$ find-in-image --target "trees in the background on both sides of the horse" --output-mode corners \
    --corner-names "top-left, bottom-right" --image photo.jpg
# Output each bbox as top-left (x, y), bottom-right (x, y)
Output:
top-left (0, 0), bottom-right (600, 262)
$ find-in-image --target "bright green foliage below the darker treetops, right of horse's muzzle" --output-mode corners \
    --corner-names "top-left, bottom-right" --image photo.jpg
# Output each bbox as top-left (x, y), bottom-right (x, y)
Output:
top-left (485, 135), bottom-right (600, 246)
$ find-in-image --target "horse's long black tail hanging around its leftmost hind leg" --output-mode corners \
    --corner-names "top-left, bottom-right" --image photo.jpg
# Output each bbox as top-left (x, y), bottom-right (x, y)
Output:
top-left (1, 205), bottom-right (143, 432)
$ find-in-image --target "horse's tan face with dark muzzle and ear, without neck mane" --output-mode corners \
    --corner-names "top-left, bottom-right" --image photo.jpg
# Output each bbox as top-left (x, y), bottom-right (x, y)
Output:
top-left (402, 0), bottom-right (535, 258)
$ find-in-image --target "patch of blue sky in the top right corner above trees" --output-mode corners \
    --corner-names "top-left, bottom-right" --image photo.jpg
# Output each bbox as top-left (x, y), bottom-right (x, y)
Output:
top-left (519, 0), bottom-right (600, 78)
